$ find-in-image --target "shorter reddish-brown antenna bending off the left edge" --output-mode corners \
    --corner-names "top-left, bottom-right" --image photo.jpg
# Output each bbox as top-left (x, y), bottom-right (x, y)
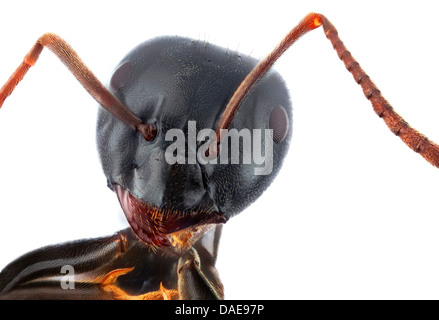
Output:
top-left (0, 33), bottom-right (156, 140)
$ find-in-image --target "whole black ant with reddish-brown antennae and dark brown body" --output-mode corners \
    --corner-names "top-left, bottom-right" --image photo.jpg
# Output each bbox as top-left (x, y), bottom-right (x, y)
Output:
top-left (0, 13), bottom-right (439, 299)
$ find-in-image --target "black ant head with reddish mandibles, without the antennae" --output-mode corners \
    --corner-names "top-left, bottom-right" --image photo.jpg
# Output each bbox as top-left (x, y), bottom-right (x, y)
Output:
top-left (97, 37), bottom-right (292, 250)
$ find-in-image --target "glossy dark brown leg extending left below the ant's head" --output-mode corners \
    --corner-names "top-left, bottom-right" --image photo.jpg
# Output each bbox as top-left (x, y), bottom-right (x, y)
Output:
top-left (0, 231), bottom-right (131, 300)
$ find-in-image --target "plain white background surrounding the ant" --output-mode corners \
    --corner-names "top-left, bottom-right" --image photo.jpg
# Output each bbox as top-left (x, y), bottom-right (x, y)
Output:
top-left (0, 1), bottom-right (439, 299)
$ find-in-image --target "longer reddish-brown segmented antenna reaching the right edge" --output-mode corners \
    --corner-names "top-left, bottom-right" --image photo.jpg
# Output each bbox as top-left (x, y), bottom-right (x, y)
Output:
top-left (215, 13), bottom-right (439, 167)
